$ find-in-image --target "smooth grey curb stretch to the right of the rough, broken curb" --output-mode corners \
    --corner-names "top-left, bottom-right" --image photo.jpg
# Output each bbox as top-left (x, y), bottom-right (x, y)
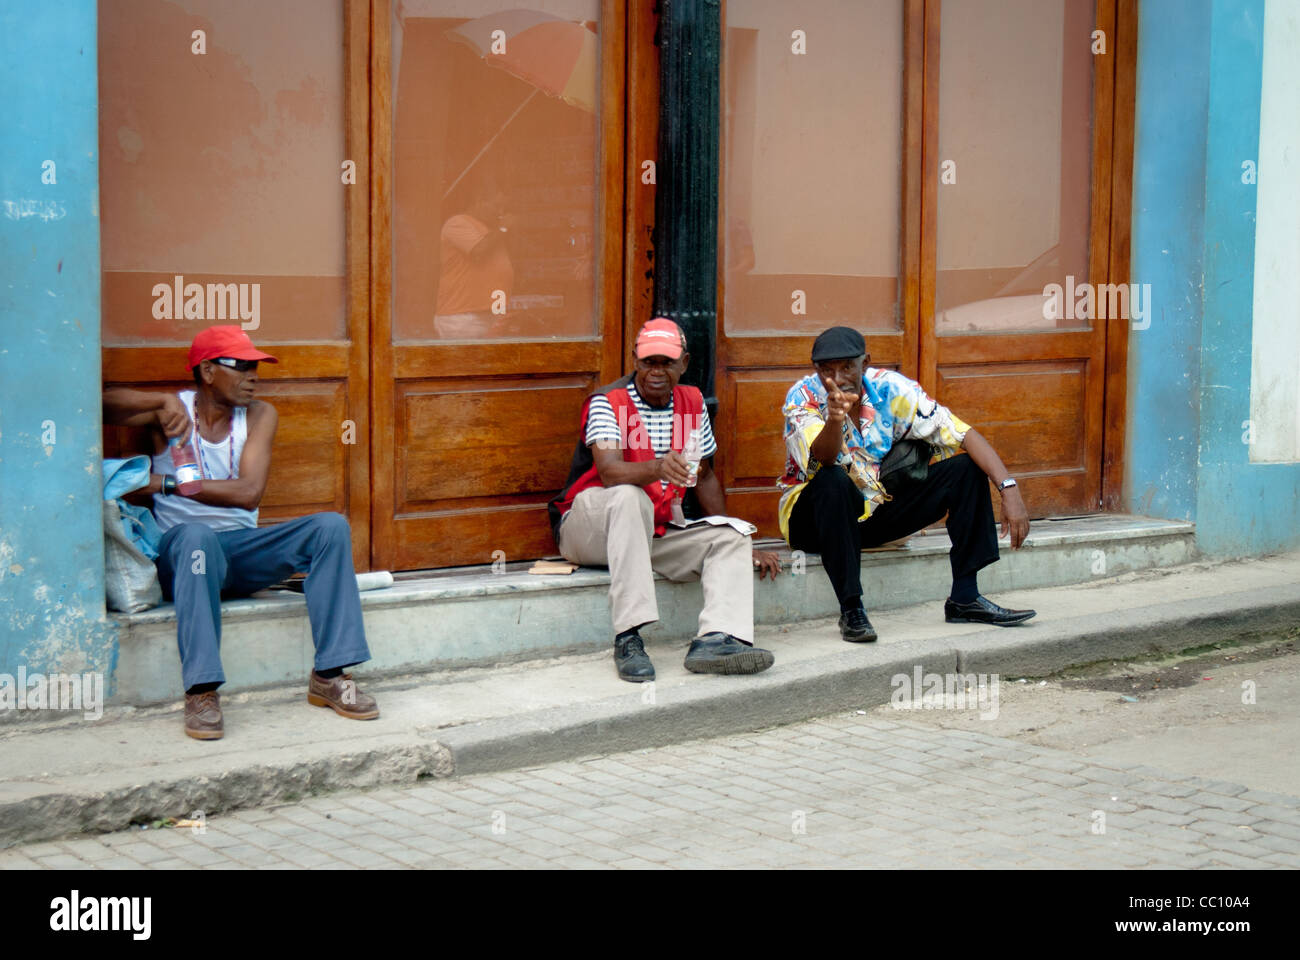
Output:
top-left (439, 585), bottom-right (1300, 775)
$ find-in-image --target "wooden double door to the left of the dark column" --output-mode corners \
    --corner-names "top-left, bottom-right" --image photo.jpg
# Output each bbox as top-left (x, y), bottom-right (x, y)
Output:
top-left (100, 0), bottom-right (634, 570)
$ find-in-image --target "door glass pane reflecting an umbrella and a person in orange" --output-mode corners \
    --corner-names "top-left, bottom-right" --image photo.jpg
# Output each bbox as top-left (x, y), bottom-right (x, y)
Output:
top-left (393, 0), bottom-right (599, 341)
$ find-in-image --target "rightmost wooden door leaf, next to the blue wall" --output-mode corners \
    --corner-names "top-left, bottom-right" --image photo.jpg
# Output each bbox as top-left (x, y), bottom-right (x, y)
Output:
top-left (919, 0), bottom-right (1127, 516)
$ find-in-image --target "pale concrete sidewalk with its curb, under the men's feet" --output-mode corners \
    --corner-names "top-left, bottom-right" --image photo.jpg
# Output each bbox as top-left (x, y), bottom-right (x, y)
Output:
top-left (0, 554), bottom-right (1300, 846)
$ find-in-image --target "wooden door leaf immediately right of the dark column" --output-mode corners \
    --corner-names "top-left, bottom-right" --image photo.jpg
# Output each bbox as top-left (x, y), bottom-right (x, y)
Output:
top-left (718, 0), bottom-right (923, 536)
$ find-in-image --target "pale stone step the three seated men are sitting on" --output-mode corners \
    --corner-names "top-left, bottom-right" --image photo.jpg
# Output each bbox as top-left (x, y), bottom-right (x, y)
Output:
top-left (108, 514), bottom-right (1195, 705)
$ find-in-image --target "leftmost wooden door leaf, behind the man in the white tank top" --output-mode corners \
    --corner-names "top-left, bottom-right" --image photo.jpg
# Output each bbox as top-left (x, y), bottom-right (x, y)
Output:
top-left (99, 0), bottom-right (371, 570)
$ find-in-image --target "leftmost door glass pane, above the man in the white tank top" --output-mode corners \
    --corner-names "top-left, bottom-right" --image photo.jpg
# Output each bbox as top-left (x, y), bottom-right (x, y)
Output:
top-left (99, 0), bottom-right (348, 346)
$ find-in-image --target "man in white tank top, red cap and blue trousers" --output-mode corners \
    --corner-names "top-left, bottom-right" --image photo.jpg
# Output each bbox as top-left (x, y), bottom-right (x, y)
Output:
top-left (104, 325), bottom-right (380, 740)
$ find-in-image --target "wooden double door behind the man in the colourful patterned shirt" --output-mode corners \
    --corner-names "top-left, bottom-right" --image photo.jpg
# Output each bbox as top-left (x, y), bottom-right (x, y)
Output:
top-left (718, 0), bottom-right (1134, 536)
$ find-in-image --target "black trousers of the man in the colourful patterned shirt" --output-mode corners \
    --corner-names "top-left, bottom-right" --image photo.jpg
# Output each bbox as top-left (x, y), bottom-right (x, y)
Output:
top-left (789, 454), bottom-right (997, 604)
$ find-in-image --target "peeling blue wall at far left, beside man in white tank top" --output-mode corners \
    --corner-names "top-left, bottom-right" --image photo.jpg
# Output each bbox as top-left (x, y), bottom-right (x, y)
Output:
top-left (0, 0), bottom-right (116, 674)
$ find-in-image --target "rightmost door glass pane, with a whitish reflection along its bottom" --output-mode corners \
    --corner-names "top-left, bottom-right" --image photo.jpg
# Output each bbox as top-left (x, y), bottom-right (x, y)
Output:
top-left (935, 0), bottom-right (1093, 336)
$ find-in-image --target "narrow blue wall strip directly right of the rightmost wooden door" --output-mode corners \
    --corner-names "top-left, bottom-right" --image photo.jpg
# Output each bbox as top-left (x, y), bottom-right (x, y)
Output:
top-left (1125, 0), bottom-right (1210, 520)
